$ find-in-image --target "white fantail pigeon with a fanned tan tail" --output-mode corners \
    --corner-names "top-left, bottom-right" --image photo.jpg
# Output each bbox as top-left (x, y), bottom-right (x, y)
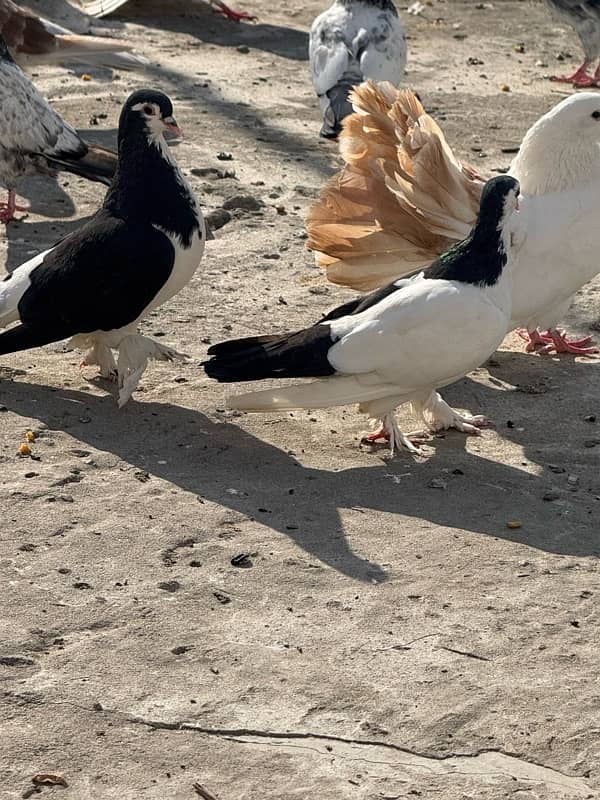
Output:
top-left (308, 83), bottom-right (600, 355)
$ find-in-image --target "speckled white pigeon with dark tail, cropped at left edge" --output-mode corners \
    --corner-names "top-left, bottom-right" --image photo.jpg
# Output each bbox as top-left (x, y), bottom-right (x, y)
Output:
top-left (0, 36), bottom-right (117, 223)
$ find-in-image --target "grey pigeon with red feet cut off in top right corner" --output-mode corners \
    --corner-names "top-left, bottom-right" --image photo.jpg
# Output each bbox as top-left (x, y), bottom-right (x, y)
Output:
top-left (546, 0), bottom-right (600, 87)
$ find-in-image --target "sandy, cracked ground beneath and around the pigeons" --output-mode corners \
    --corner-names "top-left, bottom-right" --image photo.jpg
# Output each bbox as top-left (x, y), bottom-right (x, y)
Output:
top-left (0, 0), bottom-right (600, 800)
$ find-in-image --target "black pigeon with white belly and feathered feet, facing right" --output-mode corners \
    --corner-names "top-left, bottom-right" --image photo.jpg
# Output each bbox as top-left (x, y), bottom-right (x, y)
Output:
top-left (0, 89), bottom-right (206, 406)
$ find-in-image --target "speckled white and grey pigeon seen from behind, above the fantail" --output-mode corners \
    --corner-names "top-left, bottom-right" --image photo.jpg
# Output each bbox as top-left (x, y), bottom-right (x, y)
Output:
top-left (309, 0), bottom-right (406, 139)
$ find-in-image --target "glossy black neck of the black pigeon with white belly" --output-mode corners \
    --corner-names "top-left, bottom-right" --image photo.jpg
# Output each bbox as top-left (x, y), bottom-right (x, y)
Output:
top-left (104, 130), bottom-right (200, 247)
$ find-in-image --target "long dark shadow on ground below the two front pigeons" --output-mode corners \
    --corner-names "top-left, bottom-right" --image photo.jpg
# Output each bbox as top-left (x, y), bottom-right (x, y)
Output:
top-left (1, 365), bottom-right (600, 582)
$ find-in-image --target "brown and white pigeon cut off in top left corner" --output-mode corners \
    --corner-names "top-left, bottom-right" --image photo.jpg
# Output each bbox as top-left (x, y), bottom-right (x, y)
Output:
top-left (0, 0), bottom-right (148, 69)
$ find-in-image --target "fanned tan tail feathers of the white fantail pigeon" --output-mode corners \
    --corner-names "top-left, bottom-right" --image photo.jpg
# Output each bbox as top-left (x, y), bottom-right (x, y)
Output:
top-left (307, 81), bottom-right (484, 290)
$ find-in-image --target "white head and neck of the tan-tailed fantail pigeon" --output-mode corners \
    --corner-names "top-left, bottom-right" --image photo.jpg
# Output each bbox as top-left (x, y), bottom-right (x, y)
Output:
top-left (510, 92), bottom-right (600, 195)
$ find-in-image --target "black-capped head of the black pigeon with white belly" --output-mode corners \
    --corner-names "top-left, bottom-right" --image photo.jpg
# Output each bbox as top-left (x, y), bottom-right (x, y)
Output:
top-left (119, 89), bottom-right (183, 145)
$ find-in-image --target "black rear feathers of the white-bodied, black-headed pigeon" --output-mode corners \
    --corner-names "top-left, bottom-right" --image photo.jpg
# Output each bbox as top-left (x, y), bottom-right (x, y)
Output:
top-left (202, 325), bottom-right (335, 383)
